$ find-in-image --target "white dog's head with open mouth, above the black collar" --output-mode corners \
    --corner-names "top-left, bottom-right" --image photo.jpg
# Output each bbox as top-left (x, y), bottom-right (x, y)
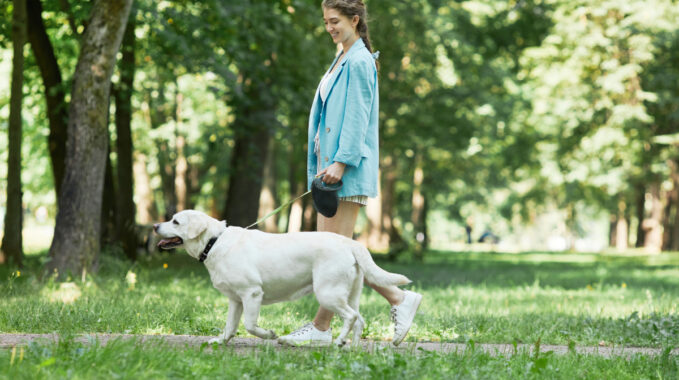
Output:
top-left (153, 210), bottom-right (212, 249)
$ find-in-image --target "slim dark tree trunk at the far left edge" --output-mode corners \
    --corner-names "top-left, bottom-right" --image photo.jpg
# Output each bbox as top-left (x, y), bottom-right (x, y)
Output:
top-left (0, 0), bottom-right (26, 267)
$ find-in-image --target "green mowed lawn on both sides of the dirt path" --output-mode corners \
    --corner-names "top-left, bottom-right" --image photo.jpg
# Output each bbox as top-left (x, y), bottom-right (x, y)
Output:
top-left (0, 251), bottom-right (679, 378)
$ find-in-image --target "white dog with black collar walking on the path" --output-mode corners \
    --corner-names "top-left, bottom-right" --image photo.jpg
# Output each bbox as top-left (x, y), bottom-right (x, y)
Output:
top-left (153, 210), bottom-right (410, 346)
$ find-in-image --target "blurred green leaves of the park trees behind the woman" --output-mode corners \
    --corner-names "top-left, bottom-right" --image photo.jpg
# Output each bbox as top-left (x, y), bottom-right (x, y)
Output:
top-left (0, 0), bottom-right (679, 249)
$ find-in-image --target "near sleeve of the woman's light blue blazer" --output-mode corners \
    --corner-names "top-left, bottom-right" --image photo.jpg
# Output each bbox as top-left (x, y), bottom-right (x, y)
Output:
top-left (333, 59), bottom-right (377, 166)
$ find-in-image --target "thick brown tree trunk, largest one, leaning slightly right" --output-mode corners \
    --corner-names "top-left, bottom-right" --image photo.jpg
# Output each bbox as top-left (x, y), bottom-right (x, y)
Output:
top-left (50, 0), bottom-right (132, 276)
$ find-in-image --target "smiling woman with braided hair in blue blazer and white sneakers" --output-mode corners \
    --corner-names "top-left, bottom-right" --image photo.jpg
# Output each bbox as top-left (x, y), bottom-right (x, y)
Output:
top-left (279, 0), bottom-right (422, 346)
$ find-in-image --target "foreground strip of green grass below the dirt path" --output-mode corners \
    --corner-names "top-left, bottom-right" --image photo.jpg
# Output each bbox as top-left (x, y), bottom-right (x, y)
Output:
top-left (0, 339), bottom-right (679, 379)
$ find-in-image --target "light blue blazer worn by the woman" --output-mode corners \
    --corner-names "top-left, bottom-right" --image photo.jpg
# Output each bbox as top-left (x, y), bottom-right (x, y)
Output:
top-left (307, 38), bottom-right (379, 197)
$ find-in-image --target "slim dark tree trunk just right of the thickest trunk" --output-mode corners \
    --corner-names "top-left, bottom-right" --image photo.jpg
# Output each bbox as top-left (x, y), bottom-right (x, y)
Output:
top-left (114, 10), bottom-right (137, 260)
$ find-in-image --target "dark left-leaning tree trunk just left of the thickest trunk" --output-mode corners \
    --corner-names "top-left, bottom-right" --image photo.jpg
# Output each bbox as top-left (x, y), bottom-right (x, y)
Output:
top-left (26, 0), bottom-right (68, 198)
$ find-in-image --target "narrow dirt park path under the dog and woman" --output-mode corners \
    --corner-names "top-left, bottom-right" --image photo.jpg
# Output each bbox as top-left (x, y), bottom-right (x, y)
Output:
top-left (0, 334), bottom-right (679, 357)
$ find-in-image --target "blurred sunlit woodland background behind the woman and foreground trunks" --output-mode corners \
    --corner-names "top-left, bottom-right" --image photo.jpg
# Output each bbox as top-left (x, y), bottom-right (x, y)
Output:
top-left (0, 0), bottom-right (679, 259)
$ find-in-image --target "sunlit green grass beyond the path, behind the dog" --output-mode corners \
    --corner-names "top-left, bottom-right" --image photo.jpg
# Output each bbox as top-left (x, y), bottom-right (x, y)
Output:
top-left (0, 248), bottom-right (679, 347)
